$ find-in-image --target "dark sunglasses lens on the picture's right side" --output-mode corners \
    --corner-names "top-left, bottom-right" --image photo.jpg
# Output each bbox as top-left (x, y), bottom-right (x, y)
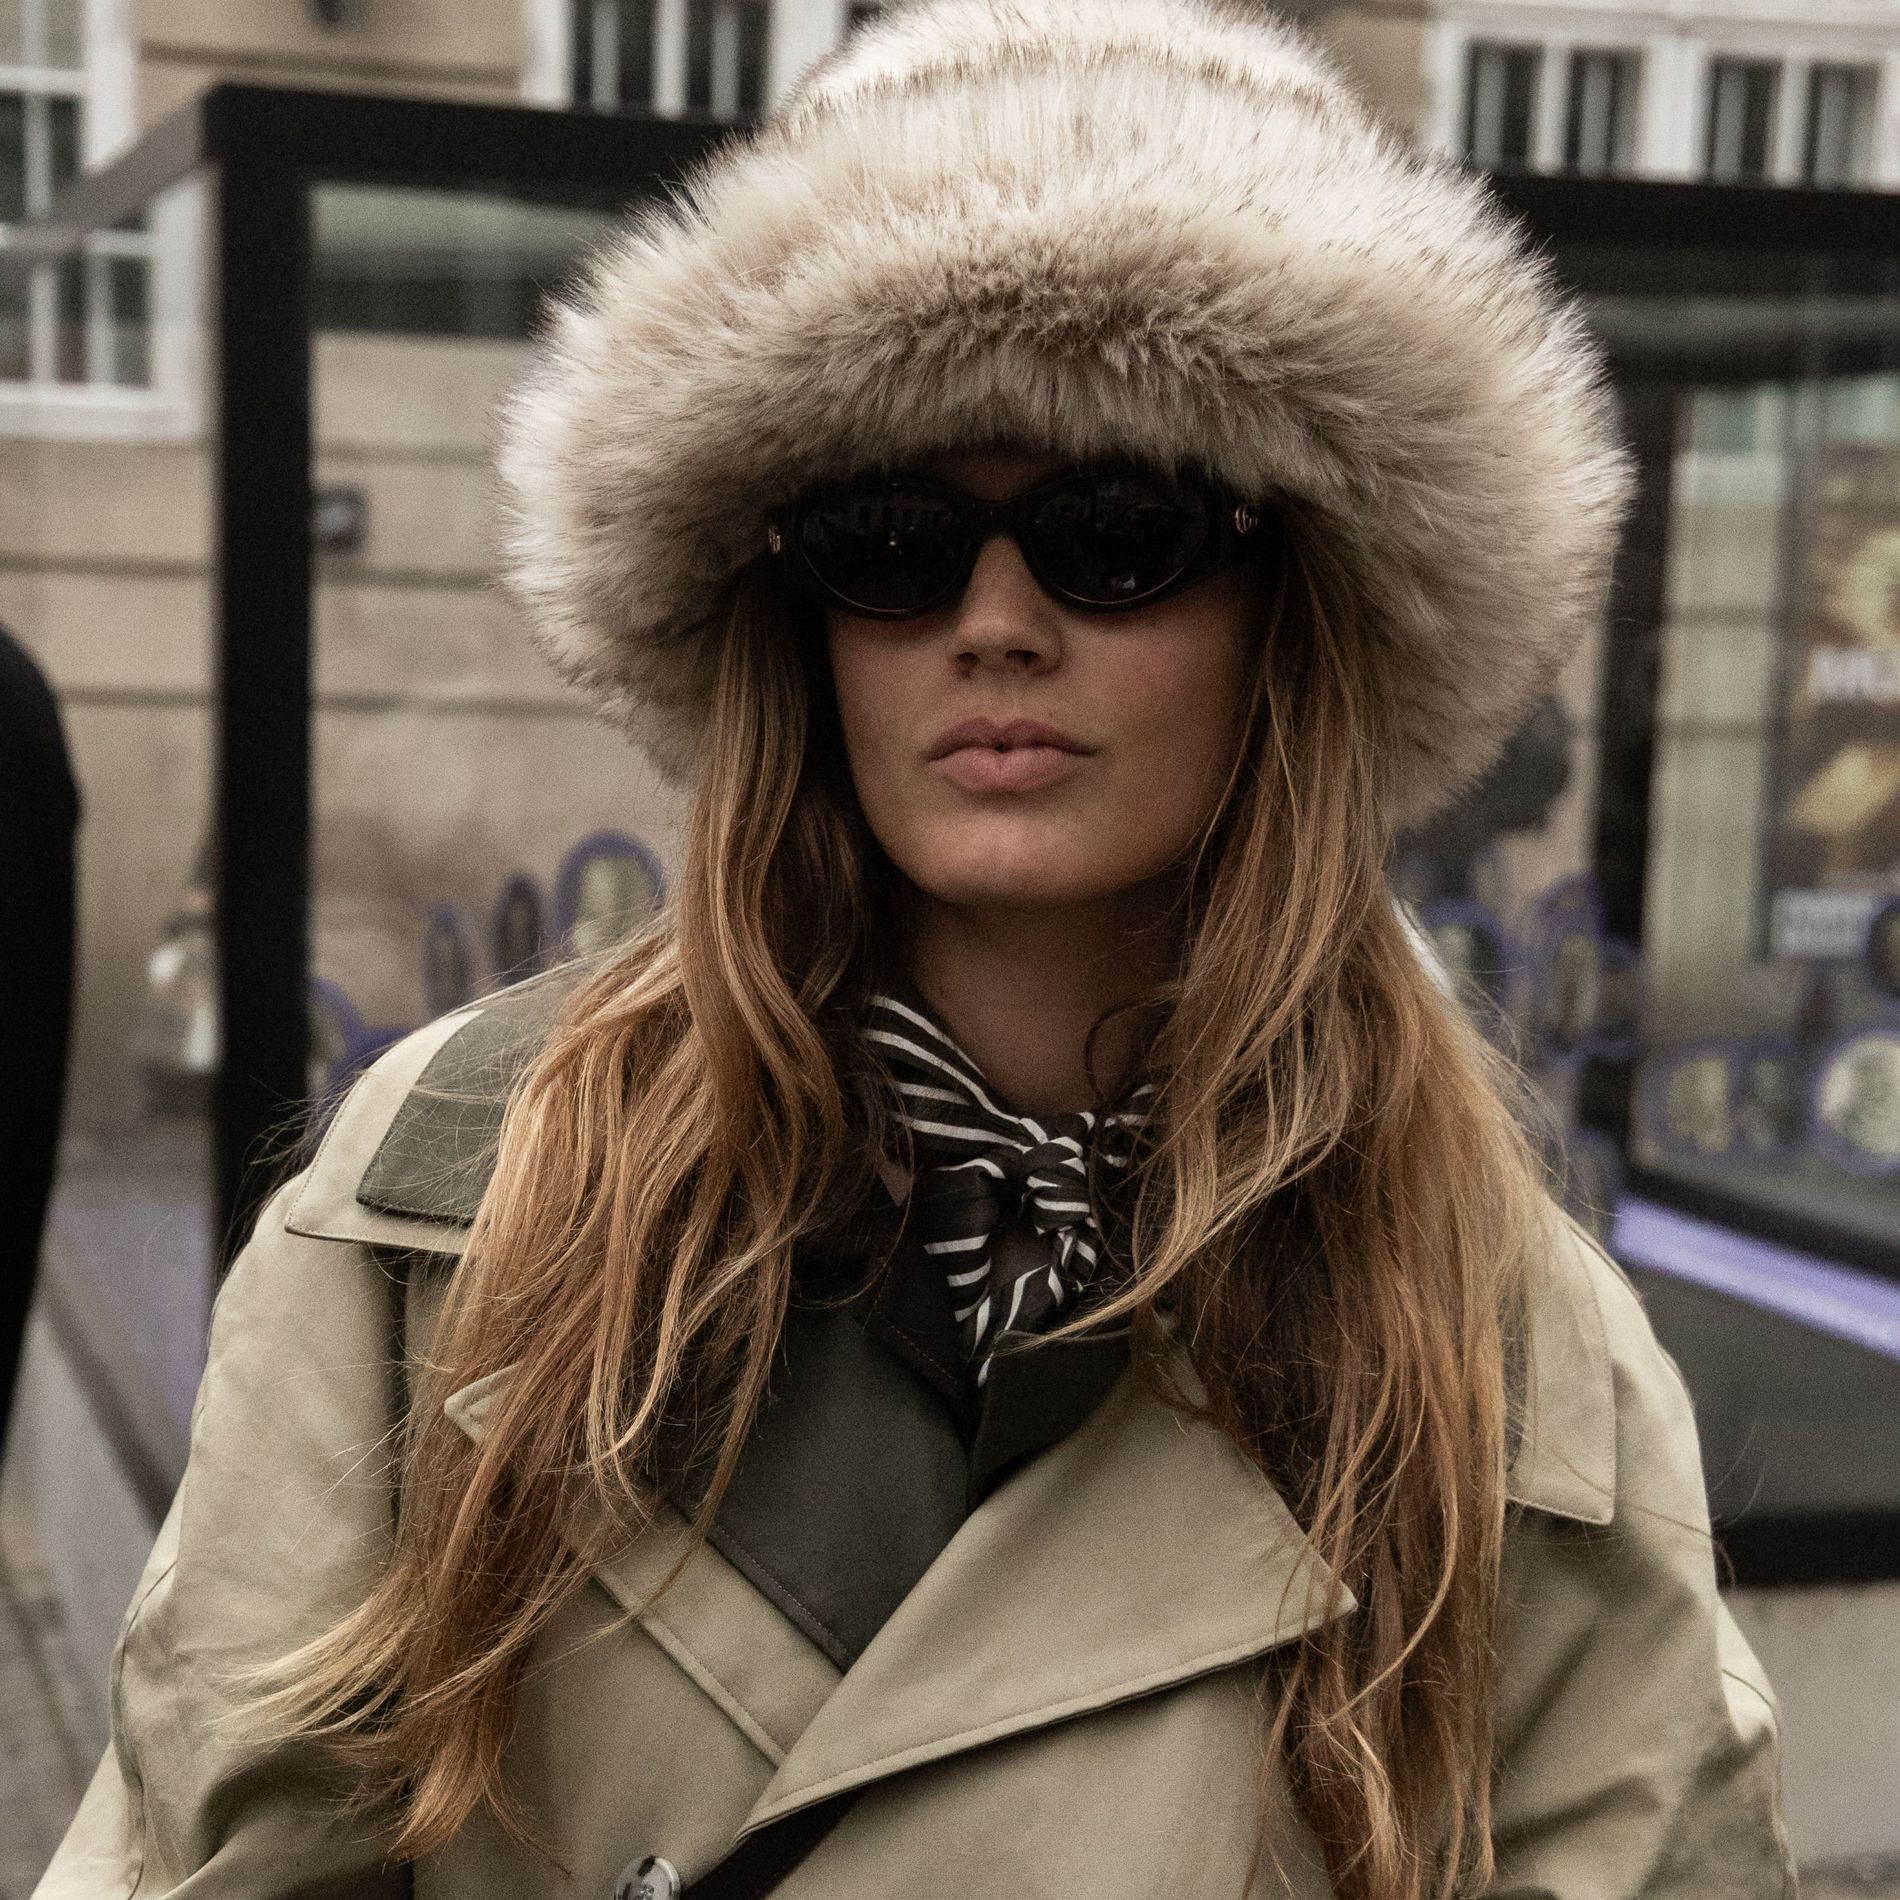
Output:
top-left (1026, 473), bottom-right (1212, 606)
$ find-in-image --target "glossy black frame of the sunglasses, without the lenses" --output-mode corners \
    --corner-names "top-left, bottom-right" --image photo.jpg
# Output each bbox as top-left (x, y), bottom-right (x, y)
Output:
top-left (766, 462), bottom-right (1264, 621)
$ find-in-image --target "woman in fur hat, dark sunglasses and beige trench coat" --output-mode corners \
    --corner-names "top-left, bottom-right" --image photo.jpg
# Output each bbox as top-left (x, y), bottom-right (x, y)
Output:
top-left (42, 0), bottom-right (1790, 1900)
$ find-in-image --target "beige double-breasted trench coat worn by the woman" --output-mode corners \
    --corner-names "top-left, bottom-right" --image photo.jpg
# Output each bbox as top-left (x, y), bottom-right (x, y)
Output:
top-left (38, 1013), bottom-right (1794, 1900)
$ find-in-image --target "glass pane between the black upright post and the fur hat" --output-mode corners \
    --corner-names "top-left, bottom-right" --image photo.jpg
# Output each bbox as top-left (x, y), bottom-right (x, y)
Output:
top-left (310, 184), bottom-right (676, 1094)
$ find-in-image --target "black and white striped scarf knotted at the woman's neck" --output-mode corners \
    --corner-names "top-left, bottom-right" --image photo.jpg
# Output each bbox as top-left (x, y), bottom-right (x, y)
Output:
top-left (863, 994), bottom-right (1151, 1387)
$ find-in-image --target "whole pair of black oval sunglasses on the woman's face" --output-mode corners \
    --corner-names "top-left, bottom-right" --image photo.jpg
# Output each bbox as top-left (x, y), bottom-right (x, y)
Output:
top-left (768, 466), bottom-right (1265, 619)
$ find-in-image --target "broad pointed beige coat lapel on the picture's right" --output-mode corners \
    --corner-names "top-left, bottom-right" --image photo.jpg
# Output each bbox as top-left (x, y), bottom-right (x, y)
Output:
top-left (729, 1372), bottom-right (1353, 1832)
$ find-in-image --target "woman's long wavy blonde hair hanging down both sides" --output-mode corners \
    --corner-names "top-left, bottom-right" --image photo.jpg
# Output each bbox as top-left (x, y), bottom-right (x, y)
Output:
top-left (264, 515), bottom-right (1545, 1900)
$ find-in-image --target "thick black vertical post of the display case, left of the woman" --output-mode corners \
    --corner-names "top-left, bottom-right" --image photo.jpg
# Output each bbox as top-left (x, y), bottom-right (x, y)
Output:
top-left (213, 152), bottom-right (312, 1264)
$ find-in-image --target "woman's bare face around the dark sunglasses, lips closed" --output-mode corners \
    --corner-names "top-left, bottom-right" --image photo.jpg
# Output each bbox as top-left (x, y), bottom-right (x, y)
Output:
top-left (827, 454), bottom-right (1256, 906)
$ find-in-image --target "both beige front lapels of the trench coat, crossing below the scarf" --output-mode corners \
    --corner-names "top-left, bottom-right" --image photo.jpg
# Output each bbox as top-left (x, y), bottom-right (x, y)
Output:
top-left (448, 1337), bottom-right (1355, 1830)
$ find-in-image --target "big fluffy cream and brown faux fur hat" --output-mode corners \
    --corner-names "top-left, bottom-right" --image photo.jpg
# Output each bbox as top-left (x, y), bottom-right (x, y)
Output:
top-left (502, 0), bottom-right (1628, 825)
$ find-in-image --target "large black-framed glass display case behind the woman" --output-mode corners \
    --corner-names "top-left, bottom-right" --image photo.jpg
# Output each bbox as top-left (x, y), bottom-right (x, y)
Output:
top-left (0, 104), bottom-right (1900, 1581)
